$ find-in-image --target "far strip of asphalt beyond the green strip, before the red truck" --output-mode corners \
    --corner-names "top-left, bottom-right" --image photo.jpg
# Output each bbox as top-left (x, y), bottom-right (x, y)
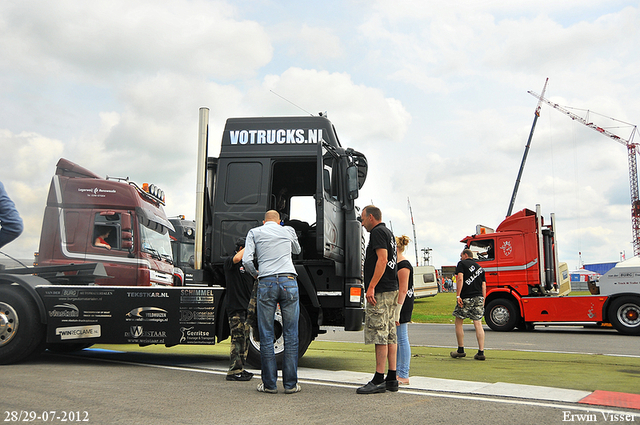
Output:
top-left (317, 323), bottom-right (640, 357)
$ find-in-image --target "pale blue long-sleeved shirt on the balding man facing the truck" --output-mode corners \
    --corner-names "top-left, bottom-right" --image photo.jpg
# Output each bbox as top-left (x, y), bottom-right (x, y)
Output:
top-left (242, 221), bottom-right (302, 278)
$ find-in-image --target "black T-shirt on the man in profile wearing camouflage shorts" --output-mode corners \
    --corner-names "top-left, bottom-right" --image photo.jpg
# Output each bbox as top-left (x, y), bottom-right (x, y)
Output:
top-left (364, 223), bottom-right (398, 294)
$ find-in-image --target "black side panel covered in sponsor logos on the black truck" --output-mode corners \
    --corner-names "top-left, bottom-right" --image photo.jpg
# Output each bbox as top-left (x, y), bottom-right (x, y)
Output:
top-left (36, 285), bottom-right (224, 346)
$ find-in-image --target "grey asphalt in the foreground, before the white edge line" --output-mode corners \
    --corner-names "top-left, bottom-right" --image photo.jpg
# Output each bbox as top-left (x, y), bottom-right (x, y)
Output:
top-left (0, 354), bottom-right (640, 425)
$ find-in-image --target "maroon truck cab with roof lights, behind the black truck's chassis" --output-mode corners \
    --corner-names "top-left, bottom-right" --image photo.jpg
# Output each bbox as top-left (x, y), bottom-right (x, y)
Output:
top-left (37, 159), bottom-right (173, 286)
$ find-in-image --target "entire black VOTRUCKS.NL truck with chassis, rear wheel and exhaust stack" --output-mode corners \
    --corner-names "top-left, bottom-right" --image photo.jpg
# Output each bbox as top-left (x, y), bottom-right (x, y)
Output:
top-left (0, 108), bottom-right (367, 365)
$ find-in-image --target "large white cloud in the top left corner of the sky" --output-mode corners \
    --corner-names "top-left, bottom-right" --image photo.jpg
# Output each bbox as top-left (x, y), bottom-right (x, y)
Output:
top-left (0, 0), bottom-right (273, 80)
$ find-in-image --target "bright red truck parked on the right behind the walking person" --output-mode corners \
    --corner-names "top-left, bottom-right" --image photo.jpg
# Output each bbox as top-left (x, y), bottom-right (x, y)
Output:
top-left (461, 205), bottom-right (640, 335)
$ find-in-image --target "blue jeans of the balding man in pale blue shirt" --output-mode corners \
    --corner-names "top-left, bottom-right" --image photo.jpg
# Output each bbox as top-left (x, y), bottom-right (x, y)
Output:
top-left (258, 275), bottom-right (300, 390)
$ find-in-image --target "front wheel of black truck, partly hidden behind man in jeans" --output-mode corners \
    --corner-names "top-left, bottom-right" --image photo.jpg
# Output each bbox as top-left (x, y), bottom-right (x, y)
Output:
top-left (247, 305), bottom-right (312, 369)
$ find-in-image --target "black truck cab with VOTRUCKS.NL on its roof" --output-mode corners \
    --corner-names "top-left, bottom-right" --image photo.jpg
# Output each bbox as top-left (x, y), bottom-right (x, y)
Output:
top-left (195, 116), bottom-right (367, 353)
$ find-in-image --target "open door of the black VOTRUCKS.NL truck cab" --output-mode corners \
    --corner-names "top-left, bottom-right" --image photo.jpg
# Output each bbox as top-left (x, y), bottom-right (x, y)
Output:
top-left (316, 144), bottom-right (344, 263)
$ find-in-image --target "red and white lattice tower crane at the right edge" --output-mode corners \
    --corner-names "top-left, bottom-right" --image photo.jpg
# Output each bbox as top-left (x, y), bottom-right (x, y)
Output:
top-left (528, 91), bottom-right (640, 256)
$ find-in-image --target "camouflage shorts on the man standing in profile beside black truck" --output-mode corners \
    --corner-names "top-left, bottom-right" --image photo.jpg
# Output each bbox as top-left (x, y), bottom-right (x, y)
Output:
top-left (364, 291), bottom-right (398, 345)
